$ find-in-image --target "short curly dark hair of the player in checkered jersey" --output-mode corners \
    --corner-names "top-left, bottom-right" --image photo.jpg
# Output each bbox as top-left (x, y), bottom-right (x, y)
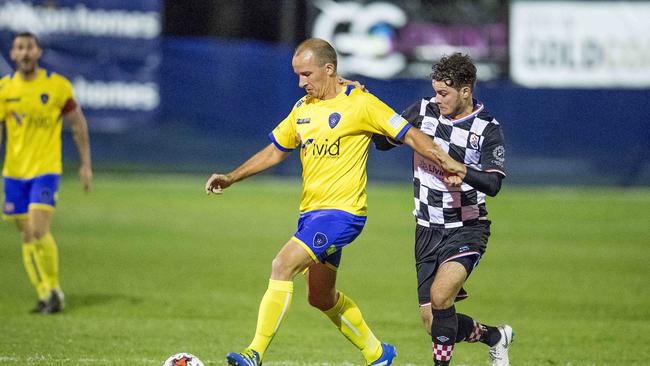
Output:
top-left (431, 52), bottom-right (476, 90)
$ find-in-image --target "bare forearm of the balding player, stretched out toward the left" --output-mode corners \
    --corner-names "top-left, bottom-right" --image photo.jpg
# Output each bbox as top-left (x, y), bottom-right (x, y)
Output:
top-left (205, 144), bottom-right (289, 194)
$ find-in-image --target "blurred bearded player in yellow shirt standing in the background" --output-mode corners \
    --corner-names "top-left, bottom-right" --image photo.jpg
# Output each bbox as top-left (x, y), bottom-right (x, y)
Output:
top-left (0, 32), bottom-right (92, 314)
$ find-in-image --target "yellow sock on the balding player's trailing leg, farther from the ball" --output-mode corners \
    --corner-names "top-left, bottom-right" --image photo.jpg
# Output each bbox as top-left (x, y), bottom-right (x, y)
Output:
top-left (324, 291), bottom-right (382, 363)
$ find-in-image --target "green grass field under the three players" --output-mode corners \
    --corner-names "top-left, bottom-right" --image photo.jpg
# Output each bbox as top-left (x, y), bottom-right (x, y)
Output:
top-left (0, 175), bottom-right (650, 366)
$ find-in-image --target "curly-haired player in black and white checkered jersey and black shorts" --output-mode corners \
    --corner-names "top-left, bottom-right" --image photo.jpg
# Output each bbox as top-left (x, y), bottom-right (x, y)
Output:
top-left (373, 53), bottom-right (514, 366)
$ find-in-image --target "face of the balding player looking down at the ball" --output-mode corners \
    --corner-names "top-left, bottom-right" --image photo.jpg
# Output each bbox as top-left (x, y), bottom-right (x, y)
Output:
top-left (291, 50), bottom-right (333, 99)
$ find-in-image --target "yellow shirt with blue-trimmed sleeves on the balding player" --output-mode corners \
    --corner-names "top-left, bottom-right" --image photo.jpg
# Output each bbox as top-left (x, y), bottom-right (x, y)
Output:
top-left (270, 86), bottom-right (410, 215)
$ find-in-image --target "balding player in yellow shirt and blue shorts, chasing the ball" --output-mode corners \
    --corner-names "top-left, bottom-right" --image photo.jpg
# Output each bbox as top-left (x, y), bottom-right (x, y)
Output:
top-left (205, 39), bottom-right (454, 366)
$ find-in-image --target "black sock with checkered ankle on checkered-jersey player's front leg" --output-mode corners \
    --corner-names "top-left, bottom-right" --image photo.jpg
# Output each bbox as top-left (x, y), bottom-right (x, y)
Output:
top-left (431, 305), bottom-right (458, 366)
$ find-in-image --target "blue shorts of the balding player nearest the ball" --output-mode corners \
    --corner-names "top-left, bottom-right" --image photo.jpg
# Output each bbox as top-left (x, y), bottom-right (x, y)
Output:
top-left (293, 210), bottom-right (366, 268)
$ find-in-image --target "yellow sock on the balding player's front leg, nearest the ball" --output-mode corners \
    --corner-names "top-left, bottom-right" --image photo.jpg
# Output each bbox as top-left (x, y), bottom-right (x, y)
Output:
top-left (248, 279), bottom-right (293, 359)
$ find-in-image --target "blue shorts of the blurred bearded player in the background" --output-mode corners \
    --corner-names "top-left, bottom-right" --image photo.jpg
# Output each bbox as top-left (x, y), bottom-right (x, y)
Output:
top-left (2, 174), bottom-right (60, 218)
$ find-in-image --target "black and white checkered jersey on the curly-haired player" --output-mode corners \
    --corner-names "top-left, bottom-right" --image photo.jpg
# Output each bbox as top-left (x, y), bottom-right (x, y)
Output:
top-left (402, 97), bottom-right (506, 228)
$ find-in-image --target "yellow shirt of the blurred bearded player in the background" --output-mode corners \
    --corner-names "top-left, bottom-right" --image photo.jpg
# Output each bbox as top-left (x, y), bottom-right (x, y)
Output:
top-left (0, 69), bottom-right (76, 179)
